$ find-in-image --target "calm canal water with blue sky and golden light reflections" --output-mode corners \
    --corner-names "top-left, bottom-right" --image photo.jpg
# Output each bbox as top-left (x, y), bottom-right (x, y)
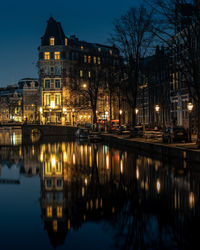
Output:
top-left (0, 130), bottom-right (200, 250)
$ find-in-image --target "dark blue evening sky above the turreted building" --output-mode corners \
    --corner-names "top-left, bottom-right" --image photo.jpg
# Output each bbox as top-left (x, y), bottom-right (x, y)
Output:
top-left (0, 0), bottom-right (142, 86)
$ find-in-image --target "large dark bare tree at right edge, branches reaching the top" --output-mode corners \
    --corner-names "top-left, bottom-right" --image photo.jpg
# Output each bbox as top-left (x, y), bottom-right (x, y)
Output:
top-left (146, 0), bottom-right (200, 145)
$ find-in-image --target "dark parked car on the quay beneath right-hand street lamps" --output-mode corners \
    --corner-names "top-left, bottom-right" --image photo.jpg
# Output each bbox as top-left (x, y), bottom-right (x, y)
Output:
top-left (162, 127), bottom-right (188, 143)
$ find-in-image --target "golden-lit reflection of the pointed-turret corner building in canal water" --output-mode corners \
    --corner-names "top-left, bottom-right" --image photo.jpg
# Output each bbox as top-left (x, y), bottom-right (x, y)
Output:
top-left (40, 142), bottom-right (129, 246)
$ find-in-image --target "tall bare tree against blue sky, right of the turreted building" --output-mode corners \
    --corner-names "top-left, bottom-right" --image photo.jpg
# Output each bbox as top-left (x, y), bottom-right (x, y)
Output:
top-left (111, 5), bottom-right (154, 126)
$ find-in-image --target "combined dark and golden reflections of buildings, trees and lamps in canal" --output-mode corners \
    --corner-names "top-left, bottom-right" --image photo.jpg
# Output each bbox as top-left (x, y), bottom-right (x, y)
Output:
top-left (0, 142), bottom-right (200, 249)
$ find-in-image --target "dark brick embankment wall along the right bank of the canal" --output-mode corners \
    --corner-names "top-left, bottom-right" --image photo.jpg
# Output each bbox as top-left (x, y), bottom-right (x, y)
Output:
top-left (102, 133), bottom-right (200, 163)
